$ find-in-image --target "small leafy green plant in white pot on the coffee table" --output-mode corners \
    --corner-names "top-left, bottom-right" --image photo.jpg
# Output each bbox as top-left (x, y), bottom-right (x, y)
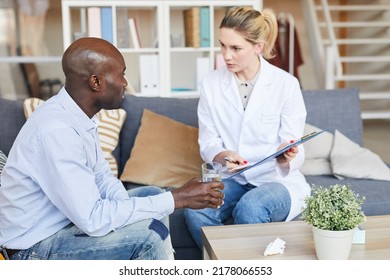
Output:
top-left (301, 184), bottom-right (366, 260)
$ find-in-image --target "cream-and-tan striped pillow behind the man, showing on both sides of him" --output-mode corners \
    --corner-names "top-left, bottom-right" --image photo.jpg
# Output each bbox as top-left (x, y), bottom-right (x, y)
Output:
top-left (23, 97), bottom-right (126, 177)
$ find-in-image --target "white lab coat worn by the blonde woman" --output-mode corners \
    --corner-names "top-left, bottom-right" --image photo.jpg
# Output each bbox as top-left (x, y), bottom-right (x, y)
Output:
top-left (198, 57), bottom-right (310, 221)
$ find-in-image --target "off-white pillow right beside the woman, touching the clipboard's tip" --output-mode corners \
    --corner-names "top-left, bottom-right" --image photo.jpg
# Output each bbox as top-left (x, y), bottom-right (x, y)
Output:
top-left (300, 124), bottom-right (333, 175)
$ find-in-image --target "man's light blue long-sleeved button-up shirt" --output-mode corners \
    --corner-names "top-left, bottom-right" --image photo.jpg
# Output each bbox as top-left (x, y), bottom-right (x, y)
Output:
top-left (0, 88), bottom-right (174, 249)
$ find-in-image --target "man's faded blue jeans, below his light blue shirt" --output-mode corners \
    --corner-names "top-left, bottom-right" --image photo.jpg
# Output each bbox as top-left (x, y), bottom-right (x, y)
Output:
top-left (12, 187), bottom-right (173, 260)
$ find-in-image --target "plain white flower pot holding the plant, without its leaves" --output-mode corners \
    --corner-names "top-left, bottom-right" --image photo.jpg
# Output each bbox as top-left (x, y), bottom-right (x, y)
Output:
top-left (312, 227), bottom-right (355, 260)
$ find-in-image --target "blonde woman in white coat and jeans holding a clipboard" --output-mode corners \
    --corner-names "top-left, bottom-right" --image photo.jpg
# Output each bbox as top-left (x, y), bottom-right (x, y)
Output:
top-left (185, 7), bottom-right (310, 247)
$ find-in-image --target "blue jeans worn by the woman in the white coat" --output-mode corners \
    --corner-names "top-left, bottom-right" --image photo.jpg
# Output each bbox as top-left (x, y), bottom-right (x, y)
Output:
top-left (184, 180), bottom-right (291, 248)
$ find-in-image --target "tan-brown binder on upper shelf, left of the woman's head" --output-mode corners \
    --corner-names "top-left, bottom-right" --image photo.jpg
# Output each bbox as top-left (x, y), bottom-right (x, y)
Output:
top-left (183, 7), bottom-right (200, 48)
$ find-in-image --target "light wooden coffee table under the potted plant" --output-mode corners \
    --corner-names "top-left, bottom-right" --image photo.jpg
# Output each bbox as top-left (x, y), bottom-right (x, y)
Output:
top-left (202, 215), bottom-right (390, 260)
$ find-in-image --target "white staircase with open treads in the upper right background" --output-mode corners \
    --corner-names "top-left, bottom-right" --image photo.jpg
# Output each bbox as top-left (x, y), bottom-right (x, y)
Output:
top-left (302, 0), bottom-right (390, 119)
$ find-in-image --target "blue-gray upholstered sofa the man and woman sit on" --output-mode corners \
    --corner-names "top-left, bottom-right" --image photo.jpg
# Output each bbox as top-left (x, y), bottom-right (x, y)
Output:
top-left (0, 89), bottom-right (390, 259)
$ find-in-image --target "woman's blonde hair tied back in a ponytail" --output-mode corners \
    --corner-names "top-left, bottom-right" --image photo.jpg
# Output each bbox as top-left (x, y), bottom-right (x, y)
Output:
top-left (219, 7), bottom-right (278, 59)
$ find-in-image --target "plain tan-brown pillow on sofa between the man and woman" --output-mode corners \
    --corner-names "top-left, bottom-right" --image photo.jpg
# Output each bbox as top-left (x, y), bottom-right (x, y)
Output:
top-left (120, 109), bottom-right (203, 187)
